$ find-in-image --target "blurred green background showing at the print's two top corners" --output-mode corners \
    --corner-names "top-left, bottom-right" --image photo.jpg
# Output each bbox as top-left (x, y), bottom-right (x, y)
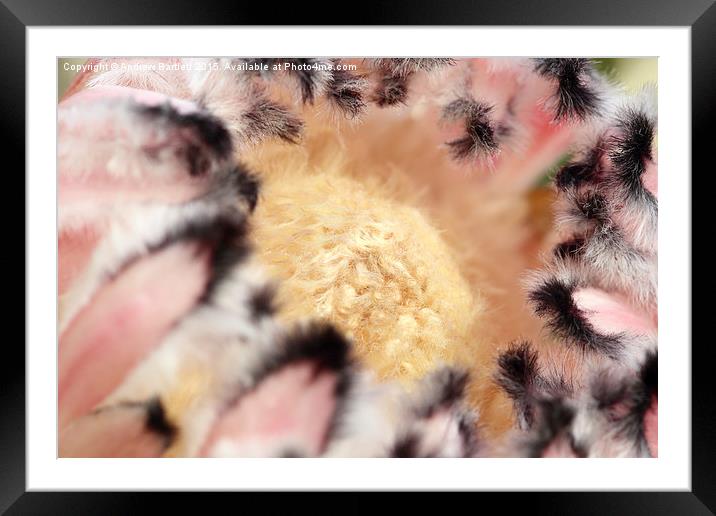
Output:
top-left (58, 57), bottom-right (657, 97)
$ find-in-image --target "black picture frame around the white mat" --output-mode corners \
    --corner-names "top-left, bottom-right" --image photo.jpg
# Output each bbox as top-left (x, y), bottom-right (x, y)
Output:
top-left (5, 0), bottom-right (716, 515)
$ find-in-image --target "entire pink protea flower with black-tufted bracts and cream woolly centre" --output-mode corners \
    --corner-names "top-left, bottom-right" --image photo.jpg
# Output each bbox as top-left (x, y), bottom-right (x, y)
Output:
top-left (58, 58), bottom-right (657, 457)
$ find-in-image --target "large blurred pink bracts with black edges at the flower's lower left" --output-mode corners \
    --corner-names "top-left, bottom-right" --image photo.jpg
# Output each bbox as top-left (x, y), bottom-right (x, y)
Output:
top-left (59, 79), bottom-right (476, 456)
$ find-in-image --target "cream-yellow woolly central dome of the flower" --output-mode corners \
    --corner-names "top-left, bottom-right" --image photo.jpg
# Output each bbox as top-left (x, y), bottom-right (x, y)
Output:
top-left (245, 134), bottom-right (482, 380)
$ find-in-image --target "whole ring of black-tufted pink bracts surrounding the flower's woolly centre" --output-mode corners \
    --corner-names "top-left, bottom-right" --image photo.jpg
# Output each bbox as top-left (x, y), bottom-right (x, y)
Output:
top-left (58, 58), bottom-right (657, 457)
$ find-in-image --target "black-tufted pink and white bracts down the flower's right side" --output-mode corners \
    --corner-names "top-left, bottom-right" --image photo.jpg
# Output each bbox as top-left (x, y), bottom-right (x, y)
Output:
top-left (496, 82), bottom-right (658, 457)
